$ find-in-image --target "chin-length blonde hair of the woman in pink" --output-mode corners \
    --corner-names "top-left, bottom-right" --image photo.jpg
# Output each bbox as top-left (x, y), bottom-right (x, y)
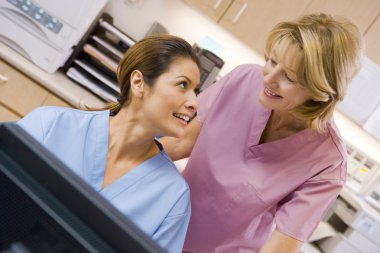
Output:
top-left (265, 13), bottom-right (364, 132)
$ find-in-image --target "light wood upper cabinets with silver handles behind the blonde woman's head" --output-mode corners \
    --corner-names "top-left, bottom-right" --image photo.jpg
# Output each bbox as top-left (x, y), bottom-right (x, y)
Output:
top-left (184, 0), bottom-right (380, 58)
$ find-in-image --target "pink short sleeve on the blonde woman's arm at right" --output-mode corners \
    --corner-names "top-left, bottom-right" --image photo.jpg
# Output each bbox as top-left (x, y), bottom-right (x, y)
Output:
top-left (275, 173), bottom-right (344, 242)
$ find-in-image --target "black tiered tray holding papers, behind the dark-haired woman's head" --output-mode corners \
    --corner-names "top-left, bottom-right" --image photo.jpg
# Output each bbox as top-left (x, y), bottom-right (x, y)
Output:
top-left (65, 14), bottom-right (135, 102)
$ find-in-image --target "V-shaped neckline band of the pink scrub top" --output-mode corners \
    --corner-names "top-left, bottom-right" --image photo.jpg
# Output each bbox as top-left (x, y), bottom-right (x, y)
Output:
top-left (248, 105), bottom-right (322, 157)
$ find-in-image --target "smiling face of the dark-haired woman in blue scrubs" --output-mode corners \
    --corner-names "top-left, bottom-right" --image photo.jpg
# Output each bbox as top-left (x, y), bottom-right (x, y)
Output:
top-left (144, 58), bottom-right (200, 137)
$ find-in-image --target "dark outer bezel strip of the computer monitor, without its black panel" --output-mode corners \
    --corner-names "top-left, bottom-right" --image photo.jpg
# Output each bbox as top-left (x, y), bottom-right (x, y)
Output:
top-left (0, 123), bottom-right (164, 253)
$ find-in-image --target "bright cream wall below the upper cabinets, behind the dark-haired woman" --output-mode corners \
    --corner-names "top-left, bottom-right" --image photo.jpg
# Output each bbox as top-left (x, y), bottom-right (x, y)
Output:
top-left (105, 0), bottom-right (264, 75)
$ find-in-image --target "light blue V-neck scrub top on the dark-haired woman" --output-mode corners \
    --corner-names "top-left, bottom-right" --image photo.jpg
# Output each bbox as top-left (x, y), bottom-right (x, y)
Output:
top-left (18, 107), bottom-right (191, 253)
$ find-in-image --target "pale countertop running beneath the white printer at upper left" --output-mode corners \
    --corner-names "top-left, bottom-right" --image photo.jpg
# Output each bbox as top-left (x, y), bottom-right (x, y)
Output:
top-left (0, 42), bottom-right (104, 108)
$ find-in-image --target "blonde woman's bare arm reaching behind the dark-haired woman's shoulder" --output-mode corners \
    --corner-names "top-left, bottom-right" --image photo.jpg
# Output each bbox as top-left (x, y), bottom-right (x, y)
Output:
top-left (160, 117), bottom-right (201, 161)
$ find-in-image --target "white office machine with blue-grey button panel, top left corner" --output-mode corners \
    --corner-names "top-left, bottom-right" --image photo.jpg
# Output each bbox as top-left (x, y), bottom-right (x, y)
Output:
top-left (0, 0), bottom-right (108, 73)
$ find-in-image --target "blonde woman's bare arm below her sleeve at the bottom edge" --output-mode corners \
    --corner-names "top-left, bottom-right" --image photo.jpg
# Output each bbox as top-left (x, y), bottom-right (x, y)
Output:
top-left (259, 230), bottom-right (302, 253)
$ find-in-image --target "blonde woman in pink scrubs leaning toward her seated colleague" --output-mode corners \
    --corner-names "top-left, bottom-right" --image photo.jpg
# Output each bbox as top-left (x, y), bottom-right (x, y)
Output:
top-left (162, 14), bottom-right (363, 253)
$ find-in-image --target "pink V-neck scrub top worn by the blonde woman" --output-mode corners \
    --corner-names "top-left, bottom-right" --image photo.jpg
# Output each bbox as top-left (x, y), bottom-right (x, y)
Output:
top-left (183, 65), bottom-right (346, 253)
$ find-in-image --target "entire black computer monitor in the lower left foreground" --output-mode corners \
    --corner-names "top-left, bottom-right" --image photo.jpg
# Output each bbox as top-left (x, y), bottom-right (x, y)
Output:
top-left (0, 123), bottom-right (164, 253)
